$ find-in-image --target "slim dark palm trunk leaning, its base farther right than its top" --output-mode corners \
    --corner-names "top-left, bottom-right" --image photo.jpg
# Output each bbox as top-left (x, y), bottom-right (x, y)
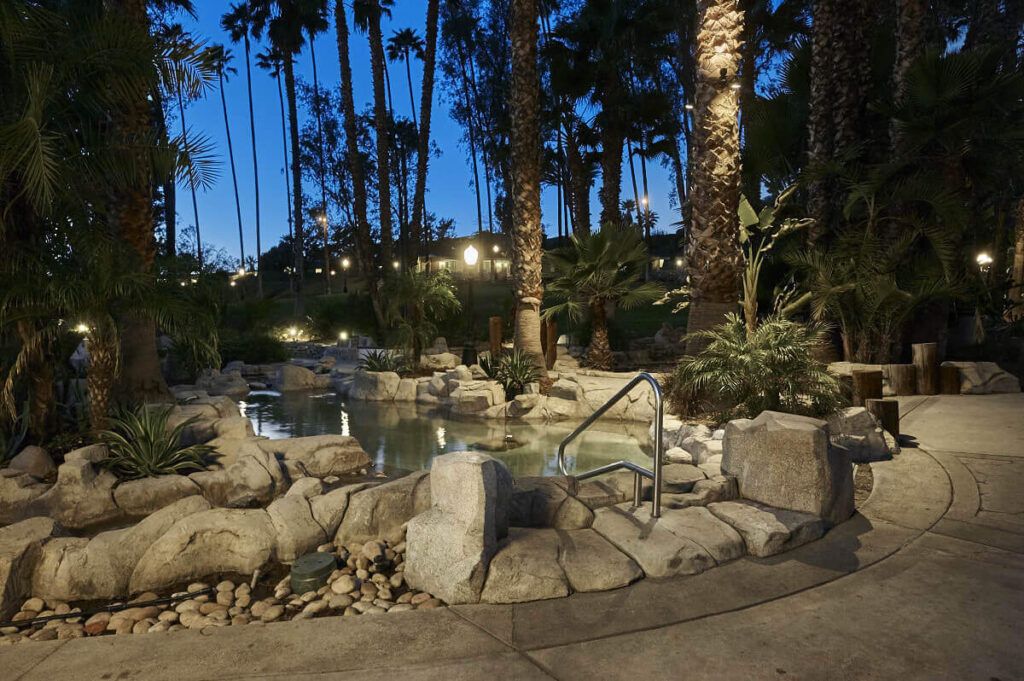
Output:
top-left (334, 0), bottom-right (385, 330)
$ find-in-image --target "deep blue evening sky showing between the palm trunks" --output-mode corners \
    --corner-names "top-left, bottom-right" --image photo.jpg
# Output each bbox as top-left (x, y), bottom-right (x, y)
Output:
top-left (179, 0), bottom-right (679, 258)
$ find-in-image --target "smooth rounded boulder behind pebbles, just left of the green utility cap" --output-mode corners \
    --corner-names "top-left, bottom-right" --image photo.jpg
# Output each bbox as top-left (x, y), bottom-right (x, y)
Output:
top-left (129, 508), bottom-right (275, 593)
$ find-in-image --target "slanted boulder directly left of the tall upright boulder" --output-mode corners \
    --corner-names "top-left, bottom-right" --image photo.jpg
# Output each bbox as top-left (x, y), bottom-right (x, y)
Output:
top-left (335, 471), bottom-right (430, 546)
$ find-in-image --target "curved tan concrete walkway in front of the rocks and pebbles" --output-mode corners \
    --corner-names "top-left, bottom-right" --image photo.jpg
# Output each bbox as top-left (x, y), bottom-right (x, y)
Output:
top-left (0, 395), bottom-right (1024, 681)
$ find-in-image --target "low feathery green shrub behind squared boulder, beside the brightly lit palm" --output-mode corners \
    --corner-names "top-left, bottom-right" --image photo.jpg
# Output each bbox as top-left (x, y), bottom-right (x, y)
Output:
top-left (666, 314), bottom-right (844, 418)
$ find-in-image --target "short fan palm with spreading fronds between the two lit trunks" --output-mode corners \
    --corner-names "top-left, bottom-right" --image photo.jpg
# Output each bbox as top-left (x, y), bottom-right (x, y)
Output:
top-left (544, 222), bottom-right (664, 371)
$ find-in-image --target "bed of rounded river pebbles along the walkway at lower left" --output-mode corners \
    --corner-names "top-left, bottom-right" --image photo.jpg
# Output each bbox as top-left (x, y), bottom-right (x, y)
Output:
top-left (0, 541), bottom-right (444, 646)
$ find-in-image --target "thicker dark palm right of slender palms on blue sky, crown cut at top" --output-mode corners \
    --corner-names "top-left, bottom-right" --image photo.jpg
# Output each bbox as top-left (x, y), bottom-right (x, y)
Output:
top-left (251, 0), bottom-right (326, 311)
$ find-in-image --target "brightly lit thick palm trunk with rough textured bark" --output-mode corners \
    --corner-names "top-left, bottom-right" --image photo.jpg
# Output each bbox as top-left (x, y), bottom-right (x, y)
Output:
top-left (686, 0), bottom-right (743, 352)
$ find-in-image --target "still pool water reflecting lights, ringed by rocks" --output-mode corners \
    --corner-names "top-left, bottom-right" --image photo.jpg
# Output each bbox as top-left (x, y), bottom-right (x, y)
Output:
top-left (239, 391), bottom-right (650, 476)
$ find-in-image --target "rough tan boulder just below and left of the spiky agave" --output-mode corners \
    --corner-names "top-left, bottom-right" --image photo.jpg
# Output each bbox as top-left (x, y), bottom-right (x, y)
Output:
top-left (34, 458), bottom-right (124, 529)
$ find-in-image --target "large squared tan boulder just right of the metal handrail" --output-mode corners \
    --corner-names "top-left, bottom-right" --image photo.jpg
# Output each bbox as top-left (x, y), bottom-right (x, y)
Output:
top-left (722, 412), bottom-right (853, 524)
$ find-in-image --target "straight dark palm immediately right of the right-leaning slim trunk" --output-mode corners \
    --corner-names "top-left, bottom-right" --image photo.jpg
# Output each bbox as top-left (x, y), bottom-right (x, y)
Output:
top-left (354, 0), bottom-right (392, 262)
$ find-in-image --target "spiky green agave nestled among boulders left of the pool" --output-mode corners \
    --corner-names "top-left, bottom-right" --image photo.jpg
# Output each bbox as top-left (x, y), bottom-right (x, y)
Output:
top-left (98, 406), bottom-right (214, 480)
